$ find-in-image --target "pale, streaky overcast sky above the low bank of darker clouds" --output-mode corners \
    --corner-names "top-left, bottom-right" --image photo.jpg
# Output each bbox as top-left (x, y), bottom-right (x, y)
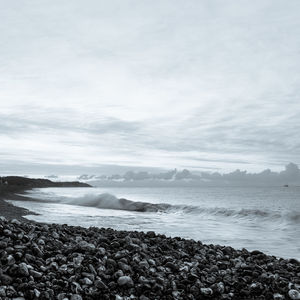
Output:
top-left (0, 0), bottom-right (300, 173)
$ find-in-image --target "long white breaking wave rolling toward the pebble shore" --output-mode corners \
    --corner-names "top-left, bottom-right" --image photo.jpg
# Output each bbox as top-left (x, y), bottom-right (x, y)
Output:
top-left (23, 193), bottom-right (300, 223)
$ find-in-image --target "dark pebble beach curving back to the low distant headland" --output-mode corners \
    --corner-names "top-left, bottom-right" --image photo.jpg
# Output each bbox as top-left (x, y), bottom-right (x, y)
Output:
top-left (0, 177), bottom-right (300, 300)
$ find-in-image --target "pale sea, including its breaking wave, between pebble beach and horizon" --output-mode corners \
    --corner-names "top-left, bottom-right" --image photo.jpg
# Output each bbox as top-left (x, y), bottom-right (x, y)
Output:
top-left (5, 187), bottom-right (300, 259)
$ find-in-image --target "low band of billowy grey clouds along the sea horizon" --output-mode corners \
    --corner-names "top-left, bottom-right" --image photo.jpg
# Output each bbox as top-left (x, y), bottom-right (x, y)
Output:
top-left (72, 163), bottom-right (300, 187)
